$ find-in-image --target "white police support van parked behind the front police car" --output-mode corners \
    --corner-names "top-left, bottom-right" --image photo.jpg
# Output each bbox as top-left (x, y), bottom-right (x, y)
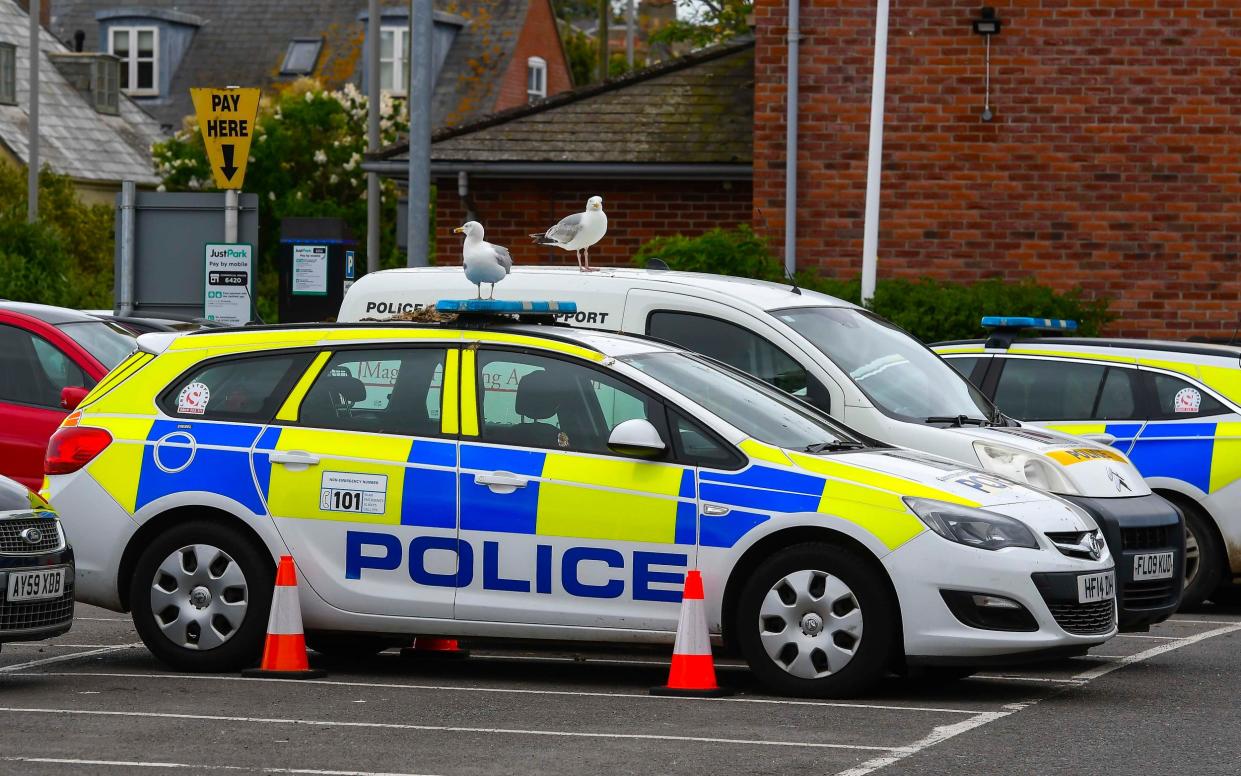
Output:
top-left (339, 267), bottom-right (1184, 629)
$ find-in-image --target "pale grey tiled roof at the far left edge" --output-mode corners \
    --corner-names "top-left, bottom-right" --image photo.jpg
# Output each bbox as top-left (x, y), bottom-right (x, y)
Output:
top-left (0, 0), bottom-right (161, 185)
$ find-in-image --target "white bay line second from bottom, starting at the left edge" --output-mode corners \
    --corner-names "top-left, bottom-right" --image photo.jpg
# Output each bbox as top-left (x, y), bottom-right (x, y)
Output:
top-left (0, 706), bottom-right (906, 752)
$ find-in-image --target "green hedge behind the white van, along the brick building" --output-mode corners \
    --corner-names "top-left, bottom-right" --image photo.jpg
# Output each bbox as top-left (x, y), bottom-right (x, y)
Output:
top-left (634, 225), bottom-right (1114, 343)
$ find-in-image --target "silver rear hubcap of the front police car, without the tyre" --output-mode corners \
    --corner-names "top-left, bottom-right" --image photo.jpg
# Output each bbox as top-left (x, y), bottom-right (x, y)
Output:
top-left (151, 544), bottom-right (249, 649)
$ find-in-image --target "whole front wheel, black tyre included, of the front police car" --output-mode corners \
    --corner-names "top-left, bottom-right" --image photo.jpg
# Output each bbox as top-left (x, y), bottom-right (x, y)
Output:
top-left (733, 543), bottom-right (900, 698)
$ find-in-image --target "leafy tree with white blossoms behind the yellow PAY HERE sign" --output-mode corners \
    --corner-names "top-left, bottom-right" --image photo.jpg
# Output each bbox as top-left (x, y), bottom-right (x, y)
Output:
top-left (153, 78), bottom-right (409, 320)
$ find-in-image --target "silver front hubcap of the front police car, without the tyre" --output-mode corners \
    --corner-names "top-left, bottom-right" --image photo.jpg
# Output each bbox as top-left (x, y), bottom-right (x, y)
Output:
top-left (758, 570), bottom-right (862, 679)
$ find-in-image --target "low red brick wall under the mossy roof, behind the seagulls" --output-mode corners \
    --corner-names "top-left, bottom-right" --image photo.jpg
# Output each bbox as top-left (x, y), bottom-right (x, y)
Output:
top-left (436, 178), bottom-right (752, 266)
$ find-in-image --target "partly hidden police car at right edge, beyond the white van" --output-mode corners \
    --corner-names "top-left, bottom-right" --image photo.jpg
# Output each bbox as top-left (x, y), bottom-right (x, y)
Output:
top-left (933, 317), bottom-right (1241, 606)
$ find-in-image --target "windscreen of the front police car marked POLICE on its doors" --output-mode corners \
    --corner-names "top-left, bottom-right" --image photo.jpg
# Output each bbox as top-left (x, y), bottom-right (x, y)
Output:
top-left (622, 353), bottom-right (861, 452)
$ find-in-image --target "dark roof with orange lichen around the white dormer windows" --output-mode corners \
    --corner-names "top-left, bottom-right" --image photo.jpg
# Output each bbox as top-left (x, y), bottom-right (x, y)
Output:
top-left (52, 0), bottom-right (530, 128)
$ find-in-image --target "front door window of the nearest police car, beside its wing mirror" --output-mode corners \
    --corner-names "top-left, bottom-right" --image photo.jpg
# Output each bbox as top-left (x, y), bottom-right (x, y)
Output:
top-left (478, 350), bottom-right (663, 456)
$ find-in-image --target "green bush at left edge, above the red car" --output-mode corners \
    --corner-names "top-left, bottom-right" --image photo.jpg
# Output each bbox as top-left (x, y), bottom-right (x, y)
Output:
top-left (0, 163), bottom-right (113, 308)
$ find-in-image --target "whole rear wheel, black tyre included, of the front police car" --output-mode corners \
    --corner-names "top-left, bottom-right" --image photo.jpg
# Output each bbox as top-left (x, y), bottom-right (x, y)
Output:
top-left (129, 520), bottom-right (276, 672)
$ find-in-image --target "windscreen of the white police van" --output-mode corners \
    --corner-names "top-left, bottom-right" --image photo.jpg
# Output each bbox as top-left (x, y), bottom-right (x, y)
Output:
top-left (772, 307), bottom-right (995, 422)
